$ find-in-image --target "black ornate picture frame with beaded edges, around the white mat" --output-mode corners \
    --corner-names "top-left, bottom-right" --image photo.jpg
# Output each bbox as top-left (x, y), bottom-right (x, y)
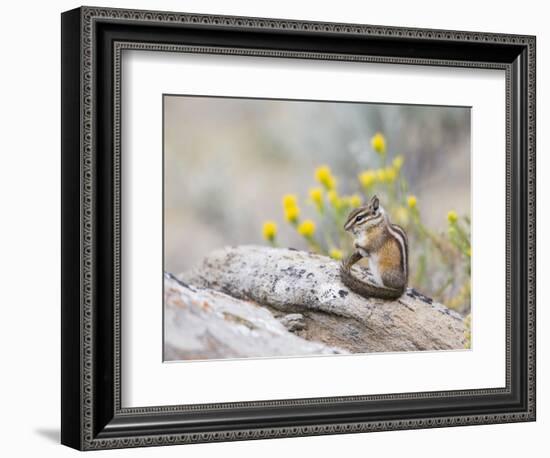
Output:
top-left (61, 7), bottom-right (535, 450)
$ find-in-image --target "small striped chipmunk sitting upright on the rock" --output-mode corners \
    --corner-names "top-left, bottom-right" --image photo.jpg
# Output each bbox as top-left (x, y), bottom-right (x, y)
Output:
top-left (340, 196), bottom-right (409, 299)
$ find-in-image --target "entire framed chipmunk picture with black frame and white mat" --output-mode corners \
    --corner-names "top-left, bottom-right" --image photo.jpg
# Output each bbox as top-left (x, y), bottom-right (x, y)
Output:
top-left (61, 7), bottom-right (536, 450)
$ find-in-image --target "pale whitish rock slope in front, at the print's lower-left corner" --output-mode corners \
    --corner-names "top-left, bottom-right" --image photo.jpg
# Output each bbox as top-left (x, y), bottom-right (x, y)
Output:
top-left (164, 274), bottom-right (346, 361)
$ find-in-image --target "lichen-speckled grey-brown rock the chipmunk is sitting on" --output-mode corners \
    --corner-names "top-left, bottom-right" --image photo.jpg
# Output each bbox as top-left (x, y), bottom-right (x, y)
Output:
top-left (180, 246), bottom-right (466, 353)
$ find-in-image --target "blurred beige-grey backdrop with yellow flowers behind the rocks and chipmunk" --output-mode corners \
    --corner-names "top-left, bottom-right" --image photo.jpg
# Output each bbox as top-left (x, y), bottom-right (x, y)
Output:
top-left (164, 96), bottom-right (471, 313)
